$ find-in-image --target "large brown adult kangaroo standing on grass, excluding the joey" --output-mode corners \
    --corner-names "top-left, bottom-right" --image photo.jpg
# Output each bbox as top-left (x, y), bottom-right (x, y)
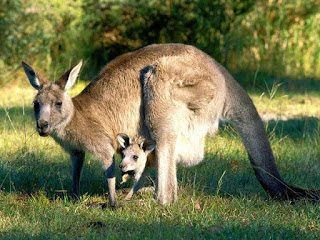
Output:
top-left (22, 44), bottom-right (319, 206)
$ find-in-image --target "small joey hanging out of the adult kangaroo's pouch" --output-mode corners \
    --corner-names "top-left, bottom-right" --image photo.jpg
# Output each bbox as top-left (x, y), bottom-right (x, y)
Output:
top-left (117, 133), bottom-right (156, 200)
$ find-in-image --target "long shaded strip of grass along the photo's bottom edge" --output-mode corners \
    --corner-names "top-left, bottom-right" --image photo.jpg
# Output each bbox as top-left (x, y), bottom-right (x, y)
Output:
top-left (0, 216), bottom-right (316, 239)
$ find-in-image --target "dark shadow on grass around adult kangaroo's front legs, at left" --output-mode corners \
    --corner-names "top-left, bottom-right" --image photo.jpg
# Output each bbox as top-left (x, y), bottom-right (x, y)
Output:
top-left (0, 149), bottom-right (107, 198)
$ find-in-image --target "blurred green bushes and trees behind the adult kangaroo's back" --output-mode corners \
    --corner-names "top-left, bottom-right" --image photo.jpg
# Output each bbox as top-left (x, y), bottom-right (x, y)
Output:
top-left (0, 0), bottom-right (320, 85)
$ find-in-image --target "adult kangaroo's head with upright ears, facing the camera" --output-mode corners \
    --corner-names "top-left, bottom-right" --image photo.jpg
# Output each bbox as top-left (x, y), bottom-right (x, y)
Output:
top-left (22, 60), bottom-right (82, 136)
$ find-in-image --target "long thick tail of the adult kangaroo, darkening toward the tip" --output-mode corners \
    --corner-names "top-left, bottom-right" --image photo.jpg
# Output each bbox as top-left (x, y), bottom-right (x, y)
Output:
top-left (223, 69), bottom-right (320, 201)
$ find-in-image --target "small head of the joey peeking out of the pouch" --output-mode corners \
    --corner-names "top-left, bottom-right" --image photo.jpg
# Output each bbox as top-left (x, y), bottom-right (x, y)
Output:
top-left (117, 133), bottom-right (156, 173)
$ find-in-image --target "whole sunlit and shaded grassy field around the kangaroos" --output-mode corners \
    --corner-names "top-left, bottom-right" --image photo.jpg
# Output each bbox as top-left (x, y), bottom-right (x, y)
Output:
top-left (0, 79), bottom-right (320, 239)
